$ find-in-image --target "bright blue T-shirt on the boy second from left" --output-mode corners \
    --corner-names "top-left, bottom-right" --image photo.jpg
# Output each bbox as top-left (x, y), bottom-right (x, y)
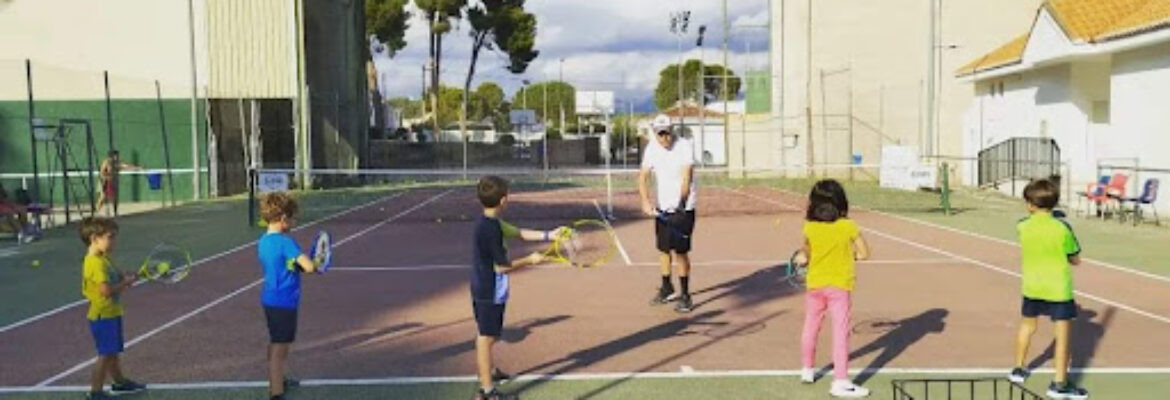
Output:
top-left (256, 232), bottom-right (302, 309)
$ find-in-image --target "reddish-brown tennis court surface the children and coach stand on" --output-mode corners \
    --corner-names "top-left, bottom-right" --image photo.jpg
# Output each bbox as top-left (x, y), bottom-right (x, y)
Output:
top-left (0, 184), bottom-right (1170, 388)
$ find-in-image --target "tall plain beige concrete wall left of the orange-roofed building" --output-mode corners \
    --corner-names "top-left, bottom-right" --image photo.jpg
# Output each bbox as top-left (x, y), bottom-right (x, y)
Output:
top-left (772, 0), bottom-right (1041, 168)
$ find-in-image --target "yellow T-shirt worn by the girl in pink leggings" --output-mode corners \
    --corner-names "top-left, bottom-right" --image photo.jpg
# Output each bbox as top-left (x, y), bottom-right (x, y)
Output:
top-left (803, 218), bottom-right (861, 290)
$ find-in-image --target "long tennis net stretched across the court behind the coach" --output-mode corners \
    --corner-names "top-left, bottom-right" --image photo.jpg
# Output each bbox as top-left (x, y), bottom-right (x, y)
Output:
top-left (252, 165), bottom-right (959, 222)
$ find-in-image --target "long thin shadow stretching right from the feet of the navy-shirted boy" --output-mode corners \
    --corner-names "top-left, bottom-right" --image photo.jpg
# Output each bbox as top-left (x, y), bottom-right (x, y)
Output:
top-left (514, 310), bottom-right (723, 393)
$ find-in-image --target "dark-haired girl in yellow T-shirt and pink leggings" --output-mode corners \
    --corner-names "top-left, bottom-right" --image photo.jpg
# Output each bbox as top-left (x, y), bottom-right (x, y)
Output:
top-left (800, 179), bottom-right (869, 398)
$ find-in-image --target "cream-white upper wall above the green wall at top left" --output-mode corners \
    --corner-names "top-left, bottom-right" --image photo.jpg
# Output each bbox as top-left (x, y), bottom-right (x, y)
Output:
top-left (0, 0), bottom-right (207, 99)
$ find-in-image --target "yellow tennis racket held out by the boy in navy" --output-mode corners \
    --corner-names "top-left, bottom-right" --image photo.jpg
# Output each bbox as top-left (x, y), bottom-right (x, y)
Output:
top-left (544, 220), bottom-right (618, 268)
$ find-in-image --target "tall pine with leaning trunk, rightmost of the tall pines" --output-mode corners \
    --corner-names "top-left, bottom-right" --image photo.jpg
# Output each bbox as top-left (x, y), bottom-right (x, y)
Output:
top-left (463, 0), bottom-right (539, 137)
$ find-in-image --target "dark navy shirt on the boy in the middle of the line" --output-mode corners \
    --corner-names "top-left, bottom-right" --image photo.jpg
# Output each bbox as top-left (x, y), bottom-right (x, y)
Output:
top-left (472, 216), bottom-right (519, 304)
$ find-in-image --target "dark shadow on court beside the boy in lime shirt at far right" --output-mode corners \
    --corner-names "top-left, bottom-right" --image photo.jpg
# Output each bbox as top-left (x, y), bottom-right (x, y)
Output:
top-left (1027, 306), bottom-right (1117, 384)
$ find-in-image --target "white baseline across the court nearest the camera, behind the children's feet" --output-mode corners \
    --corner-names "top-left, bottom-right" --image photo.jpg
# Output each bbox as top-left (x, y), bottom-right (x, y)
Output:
top-left (0, 367), bottom-right (1170, 393)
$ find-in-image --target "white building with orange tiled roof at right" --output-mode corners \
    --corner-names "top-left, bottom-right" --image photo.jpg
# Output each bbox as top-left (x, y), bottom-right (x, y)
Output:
top-left (957, 0), bottom-right (1170, 212)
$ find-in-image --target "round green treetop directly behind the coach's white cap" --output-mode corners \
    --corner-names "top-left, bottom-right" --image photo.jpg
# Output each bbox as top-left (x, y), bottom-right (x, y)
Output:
top-left (654, 60), bottom-right (742, 110)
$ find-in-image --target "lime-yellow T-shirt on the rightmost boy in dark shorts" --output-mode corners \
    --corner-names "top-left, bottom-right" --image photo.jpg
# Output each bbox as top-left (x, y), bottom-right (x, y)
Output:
top-left (1016, 212), bottom-right (1081, 302)
